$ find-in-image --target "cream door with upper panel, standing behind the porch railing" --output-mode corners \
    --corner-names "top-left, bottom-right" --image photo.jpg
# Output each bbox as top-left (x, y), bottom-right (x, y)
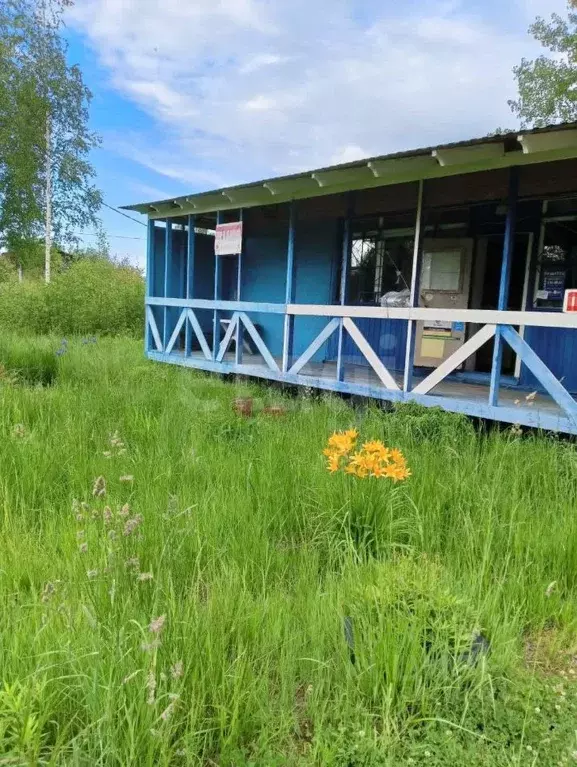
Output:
top-left (415, 237), bottom-right (473, 368)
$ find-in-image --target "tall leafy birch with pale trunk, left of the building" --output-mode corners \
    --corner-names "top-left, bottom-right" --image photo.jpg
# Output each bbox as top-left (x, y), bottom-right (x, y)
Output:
top-left (0, 0), bottom-right (100, 258)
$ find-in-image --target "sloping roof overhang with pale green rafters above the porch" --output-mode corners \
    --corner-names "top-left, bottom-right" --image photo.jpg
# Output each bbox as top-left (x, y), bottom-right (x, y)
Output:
top-left (124, 122), bottom-right (577, 218)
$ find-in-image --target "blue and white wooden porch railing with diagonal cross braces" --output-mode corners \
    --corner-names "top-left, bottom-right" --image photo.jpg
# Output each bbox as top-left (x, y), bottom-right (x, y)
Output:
top-left (146, 298), bottom-right (577, 434)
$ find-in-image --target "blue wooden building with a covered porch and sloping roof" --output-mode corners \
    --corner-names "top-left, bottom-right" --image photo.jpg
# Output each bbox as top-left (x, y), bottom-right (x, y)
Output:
top-left (128, 124), bottom-right (577, 434)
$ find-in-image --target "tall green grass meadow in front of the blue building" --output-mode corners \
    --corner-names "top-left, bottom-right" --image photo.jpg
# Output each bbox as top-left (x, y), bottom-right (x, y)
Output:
top-left (0, 336), bottom-right (577, 767)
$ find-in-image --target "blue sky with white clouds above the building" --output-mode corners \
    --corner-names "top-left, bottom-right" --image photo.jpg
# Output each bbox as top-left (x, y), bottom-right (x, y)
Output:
top-left (67, 0), bottom-right (565, 265)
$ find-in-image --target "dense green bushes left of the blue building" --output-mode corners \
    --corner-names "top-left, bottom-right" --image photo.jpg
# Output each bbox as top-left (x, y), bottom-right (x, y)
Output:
top-left (0, 258), bottom-right (144, 336)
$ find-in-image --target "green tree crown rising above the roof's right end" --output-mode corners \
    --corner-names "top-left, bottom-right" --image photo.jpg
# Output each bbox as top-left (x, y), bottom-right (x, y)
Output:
top-left (509, 3), bottom-right (577, 127)
